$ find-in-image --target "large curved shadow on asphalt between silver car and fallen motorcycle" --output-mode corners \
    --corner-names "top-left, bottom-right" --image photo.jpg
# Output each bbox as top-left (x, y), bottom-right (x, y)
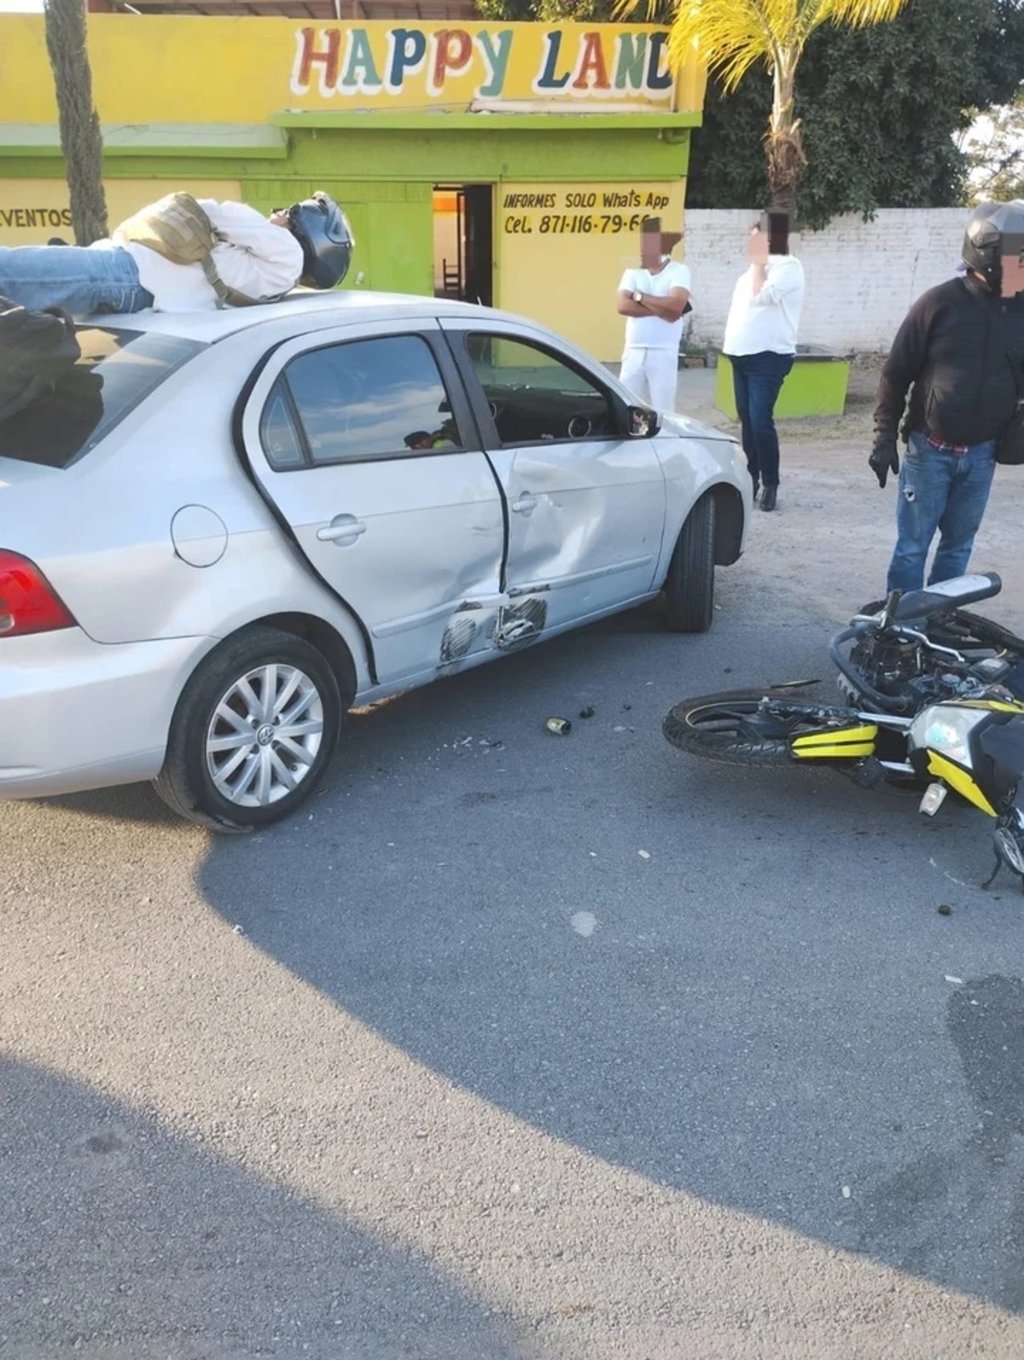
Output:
top-left (187, 620), bottom-right (1024, 1310)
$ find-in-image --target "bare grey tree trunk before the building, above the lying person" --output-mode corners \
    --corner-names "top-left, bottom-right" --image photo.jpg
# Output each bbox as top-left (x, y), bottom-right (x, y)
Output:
top-left (44, 0), bottom-right (107, 246)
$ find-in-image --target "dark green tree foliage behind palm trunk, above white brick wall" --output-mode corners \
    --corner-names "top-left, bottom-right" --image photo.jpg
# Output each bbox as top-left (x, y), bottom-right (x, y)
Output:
top-left (687, 0), bottom-right (1024, 227)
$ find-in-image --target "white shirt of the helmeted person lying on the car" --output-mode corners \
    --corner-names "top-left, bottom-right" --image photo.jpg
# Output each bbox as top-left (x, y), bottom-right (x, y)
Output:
top-left (112, 199), bottom-right (303, 311)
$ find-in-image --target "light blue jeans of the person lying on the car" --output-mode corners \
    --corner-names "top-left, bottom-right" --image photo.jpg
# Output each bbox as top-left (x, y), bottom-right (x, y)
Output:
top-left (0, 242), bottom-right (152, 317)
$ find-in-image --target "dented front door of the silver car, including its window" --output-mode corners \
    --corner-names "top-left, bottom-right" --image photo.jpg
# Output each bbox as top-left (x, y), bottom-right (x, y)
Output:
top-left (442, 320), bottom-right (666, 647)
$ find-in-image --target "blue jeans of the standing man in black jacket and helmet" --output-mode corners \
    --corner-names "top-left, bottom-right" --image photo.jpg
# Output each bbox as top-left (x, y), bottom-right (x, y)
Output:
top-left (887, 431), bottom-right (995, 590)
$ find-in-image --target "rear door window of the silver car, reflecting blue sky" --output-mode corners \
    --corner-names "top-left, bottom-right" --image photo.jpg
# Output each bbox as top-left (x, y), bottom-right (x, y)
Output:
top-left (271, 336), bottom-right (462, 472)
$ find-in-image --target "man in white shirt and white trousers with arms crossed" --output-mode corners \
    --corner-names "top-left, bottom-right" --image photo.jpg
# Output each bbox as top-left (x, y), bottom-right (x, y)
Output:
top-left (619, 218), bottom-right (689, 411)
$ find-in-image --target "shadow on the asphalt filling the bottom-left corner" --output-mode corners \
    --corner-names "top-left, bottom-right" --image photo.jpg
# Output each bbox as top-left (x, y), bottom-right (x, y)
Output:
top-left (0, 1059), bottom-right (537, 1360)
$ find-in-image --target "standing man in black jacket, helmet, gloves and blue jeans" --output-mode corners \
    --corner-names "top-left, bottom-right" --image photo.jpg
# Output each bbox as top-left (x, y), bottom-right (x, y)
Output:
top-left (868, 199), bottom-right (1024, 592)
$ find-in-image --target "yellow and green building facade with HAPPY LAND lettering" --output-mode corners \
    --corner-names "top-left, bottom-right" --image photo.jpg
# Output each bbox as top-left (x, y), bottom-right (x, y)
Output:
top-left (0, 15), bottom-right (703, 359)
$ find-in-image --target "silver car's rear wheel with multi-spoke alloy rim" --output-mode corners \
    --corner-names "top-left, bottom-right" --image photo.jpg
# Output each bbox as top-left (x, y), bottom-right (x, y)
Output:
top-left (155, 627), bottom-right (343, 831)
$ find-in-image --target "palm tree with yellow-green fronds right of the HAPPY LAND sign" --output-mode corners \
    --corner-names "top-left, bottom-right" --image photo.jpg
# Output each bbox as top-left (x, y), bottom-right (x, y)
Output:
top-left (616, 0), bottom-right (907, 215)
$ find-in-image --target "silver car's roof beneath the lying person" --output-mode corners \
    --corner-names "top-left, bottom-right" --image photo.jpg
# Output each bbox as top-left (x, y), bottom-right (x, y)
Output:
top-left (90, 288), bottom-right (544, 344)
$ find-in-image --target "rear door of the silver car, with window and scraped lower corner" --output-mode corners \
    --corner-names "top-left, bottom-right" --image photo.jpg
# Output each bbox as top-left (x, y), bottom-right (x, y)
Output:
top-left (232, 324), bottom-right (505, 684)
